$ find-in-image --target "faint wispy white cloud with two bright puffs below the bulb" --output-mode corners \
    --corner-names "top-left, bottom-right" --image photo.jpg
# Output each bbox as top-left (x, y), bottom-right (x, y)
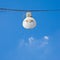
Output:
top-left (20, 36), bottom-right (49, 48)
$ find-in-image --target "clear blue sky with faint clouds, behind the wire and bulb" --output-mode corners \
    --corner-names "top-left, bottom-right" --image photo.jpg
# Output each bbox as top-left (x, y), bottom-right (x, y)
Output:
top-left (0, 0), bottom-right (60, 60)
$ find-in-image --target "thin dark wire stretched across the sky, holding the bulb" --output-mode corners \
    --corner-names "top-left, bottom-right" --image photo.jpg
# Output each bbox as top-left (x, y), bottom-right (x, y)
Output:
top-left (0, 8), bottom-right (60, 12)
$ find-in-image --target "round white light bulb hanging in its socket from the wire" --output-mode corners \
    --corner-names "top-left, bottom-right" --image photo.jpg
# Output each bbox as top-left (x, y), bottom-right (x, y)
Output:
top-left (22, 12), bottom-right (36, 29)
